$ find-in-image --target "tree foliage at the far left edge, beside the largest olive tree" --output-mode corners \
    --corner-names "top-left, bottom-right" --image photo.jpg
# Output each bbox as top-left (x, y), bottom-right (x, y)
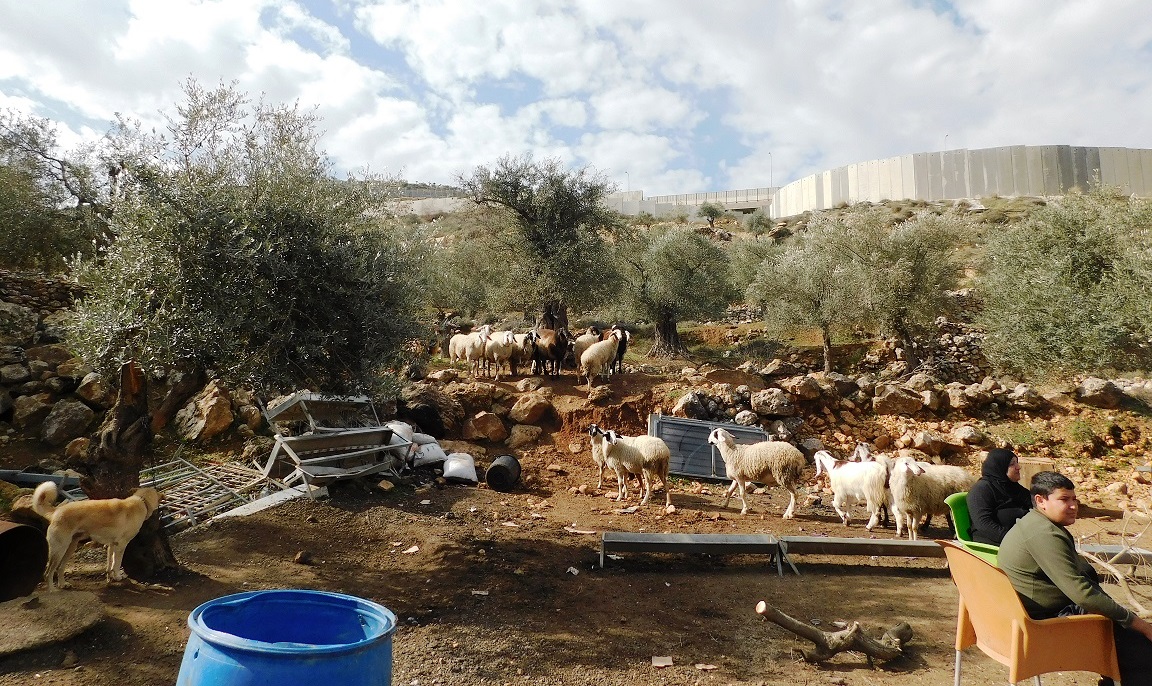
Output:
top-left (0, 112), bottom-right (105, 271)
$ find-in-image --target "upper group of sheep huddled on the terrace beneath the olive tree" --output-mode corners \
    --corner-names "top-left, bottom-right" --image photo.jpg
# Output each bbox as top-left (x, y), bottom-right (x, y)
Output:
top-left (448, 324), bottom-right (632, 391)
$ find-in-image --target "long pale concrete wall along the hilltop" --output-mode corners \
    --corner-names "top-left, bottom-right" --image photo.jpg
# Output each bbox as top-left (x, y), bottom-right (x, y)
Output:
top-left (605, 145), bottom-right (1152, 218)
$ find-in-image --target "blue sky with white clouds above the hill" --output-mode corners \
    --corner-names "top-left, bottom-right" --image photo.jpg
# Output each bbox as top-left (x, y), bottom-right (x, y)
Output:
top-left (0, 0), bottom-right (1152, 196)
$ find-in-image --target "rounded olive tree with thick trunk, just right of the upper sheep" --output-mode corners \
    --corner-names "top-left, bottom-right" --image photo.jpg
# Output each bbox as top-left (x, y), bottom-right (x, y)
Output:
top-left (616, 228), bottom-right (735, 357)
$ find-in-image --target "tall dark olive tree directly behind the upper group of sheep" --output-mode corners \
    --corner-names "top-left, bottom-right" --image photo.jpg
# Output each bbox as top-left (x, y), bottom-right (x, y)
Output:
top-left (458, 154), bottom-right (620, 329)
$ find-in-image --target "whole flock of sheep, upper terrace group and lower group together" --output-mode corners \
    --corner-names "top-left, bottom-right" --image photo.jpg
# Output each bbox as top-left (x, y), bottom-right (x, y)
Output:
top-left (448, 325), bottom-right (976, 540)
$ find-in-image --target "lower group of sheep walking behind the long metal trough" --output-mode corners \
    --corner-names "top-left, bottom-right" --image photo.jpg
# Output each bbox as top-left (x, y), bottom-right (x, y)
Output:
top-left (588, 424), bottom-right (976, 541)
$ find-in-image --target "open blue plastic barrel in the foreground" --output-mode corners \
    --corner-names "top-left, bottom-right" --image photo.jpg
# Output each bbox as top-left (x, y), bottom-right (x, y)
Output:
top-left (176, 590), bottom-right (396, 686)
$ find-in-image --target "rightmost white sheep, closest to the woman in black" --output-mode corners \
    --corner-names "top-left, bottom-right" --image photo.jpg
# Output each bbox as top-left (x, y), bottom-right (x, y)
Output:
top-left (888, 457), bottom-right (976, 541)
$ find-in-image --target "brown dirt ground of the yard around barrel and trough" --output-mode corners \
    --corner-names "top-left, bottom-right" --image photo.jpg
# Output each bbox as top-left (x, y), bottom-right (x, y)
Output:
top-left (0, 373), bottom-right (1147, 686)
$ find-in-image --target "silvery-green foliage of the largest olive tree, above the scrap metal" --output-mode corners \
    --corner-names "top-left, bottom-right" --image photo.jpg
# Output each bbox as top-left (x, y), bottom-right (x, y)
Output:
top-left (69, 82), bottom-right (420, 392)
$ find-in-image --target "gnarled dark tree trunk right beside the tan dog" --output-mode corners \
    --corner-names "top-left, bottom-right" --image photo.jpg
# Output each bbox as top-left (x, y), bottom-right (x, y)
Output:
top-left (69, 361), bottom-right (180, 580)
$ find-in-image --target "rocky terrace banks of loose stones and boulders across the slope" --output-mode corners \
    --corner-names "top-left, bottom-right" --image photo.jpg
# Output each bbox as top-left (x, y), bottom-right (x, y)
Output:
top-left (0, 268), bottom-right (1152, 516)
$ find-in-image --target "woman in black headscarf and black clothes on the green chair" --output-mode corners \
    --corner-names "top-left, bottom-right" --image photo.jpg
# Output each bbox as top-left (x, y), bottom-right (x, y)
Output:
top-left (968, 448), bottom-right (1032, 545)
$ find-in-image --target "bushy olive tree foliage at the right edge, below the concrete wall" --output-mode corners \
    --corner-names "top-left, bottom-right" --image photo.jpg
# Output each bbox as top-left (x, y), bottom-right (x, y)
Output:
top-left (979, 189), bottom-right (1152, 376)
